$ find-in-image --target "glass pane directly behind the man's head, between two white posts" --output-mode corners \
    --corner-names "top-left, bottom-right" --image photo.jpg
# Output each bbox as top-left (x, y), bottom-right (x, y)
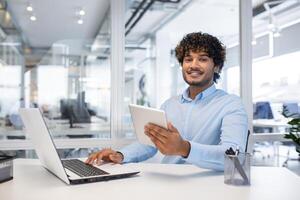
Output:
top-left (123, 0), bottom-right (240, 141)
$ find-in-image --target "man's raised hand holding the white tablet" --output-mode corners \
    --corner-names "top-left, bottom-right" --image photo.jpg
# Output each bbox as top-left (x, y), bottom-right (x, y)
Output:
top-left (144, 122), bottom-right (191, 157)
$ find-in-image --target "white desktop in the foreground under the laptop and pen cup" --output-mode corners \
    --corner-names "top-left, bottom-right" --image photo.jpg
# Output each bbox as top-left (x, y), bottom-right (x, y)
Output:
top-left (0, 159), bottom-right (300, 200)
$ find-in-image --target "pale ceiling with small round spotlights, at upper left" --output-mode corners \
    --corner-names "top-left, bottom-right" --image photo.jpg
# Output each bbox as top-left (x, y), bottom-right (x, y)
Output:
top-left (7, 0), bottom-right (109, 48)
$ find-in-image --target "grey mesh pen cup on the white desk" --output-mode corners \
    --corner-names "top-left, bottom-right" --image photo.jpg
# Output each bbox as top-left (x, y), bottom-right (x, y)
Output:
top-left (224, 153), bottom-right (251, 185)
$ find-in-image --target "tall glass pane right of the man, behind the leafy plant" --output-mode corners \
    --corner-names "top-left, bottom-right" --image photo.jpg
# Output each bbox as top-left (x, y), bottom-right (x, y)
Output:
top-left (252, 0), bottom-right (300, 170)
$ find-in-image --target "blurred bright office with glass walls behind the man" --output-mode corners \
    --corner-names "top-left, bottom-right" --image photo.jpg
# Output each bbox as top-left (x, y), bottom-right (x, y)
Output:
top-left (0, 0), bottom-right (300, 173)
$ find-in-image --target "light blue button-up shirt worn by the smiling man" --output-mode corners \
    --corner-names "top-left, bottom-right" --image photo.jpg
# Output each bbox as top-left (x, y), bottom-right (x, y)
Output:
top-left (120, 85), bottom-right (248, 170)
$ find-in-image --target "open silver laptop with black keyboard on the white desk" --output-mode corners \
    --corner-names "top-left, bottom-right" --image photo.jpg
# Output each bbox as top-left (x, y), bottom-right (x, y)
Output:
top-left (20, 108), bottom-right (139, 184)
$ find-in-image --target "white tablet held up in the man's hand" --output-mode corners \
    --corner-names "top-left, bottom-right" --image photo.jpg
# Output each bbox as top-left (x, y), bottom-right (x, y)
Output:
top-left (129, 104), bottom-right (168, 146)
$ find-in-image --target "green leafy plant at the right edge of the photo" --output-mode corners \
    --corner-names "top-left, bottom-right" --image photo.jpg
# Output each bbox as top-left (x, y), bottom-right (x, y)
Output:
top-left (282, 106), bottom-right (300, 155)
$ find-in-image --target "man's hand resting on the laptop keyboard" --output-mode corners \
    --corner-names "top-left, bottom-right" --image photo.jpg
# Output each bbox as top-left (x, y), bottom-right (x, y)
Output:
top-left (85, 149), bottom-right (123, 165)
